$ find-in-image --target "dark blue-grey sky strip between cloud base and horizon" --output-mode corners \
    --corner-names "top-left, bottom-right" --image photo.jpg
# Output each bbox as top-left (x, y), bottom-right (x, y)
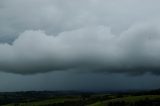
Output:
top-left (0, 71), bottom-right (160, 91)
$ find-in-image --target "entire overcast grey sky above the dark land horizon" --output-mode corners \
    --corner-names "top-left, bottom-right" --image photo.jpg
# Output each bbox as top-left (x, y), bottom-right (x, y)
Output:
top-left (0, 0), bottom-right (160, 91)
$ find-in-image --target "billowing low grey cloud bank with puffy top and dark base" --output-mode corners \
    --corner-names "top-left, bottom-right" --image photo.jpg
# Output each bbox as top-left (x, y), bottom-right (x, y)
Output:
top-left (0, 24), bottom-right (160, 74)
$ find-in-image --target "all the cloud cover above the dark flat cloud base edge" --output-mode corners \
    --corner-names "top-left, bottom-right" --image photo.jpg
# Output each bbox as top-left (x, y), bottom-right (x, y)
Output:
top-left (0, 0), bottom-right (160, 75)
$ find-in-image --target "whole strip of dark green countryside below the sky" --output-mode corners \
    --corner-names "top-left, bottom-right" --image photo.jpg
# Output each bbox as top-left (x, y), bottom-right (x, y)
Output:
top-left (0, 91), bottom-right (160, 106)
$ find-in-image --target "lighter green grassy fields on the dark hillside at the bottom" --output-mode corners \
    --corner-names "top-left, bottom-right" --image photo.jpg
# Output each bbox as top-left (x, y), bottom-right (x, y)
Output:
top-left (3, 94), bottom-right (160, 106)
